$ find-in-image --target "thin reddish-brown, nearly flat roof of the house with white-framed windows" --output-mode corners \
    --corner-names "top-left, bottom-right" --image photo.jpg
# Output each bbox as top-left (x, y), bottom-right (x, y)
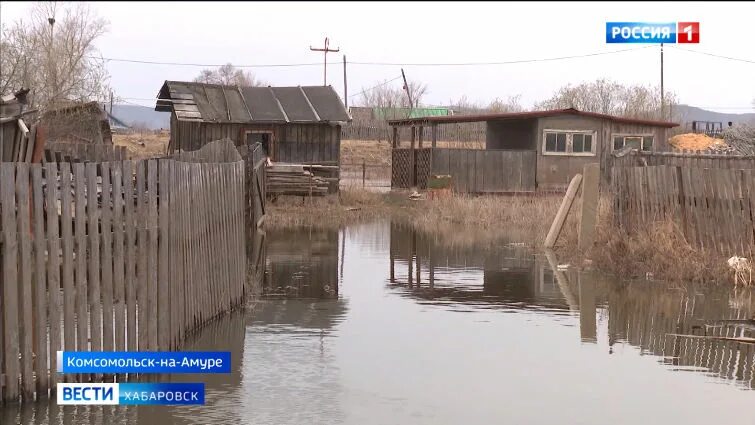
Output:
top-left (388, 108), bottom-right (679, 128)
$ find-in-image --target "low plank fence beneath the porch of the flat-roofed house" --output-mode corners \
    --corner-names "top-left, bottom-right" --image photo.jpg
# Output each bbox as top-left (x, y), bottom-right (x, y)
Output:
top-left (391, 148), bottom-right (537, 193)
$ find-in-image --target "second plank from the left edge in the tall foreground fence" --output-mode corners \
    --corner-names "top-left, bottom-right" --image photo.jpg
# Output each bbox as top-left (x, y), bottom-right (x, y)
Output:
top-left (16, 163), bottom-right (34, 400)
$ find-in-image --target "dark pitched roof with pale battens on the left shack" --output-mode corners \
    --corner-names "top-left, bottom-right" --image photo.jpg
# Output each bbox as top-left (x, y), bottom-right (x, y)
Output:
top-left (155, 81), bottom-right (351, 123)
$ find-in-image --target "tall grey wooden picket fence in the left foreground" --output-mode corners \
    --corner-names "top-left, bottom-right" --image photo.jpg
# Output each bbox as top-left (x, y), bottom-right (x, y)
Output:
top-left (0, 140), bottom-right (246, 401)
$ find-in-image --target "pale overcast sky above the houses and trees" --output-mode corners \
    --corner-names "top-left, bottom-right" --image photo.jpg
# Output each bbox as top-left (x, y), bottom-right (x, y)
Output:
top-left (0, 2), bottom-right (755, 112)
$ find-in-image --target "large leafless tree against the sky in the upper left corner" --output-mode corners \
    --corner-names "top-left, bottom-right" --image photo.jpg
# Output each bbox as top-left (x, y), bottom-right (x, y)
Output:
top-left (0, 2), bottom-right (110, 110)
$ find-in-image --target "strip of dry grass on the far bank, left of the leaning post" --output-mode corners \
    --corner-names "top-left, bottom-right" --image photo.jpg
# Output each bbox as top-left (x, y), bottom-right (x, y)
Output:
top-left (266, 188), bottom-right (579, 246)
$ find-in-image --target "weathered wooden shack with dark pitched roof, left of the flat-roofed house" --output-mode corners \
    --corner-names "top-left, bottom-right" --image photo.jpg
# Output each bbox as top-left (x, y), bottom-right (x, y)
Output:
top-left (155, 81), bottom-right (351, 165)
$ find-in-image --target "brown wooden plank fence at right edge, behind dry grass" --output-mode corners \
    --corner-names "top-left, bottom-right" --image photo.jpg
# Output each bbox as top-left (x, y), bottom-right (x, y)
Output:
top-left (611, 165), bottom-right (755, 255)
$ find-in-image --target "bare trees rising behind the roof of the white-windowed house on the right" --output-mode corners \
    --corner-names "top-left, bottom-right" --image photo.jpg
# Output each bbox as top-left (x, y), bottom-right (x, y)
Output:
top-left (535, 79), bottom-right (678, 119)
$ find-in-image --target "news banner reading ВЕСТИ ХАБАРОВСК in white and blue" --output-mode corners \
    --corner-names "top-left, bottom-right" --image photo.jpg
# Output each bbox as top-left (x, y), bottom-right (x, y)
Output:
top-left (57, 382), bottom-right (204, 405)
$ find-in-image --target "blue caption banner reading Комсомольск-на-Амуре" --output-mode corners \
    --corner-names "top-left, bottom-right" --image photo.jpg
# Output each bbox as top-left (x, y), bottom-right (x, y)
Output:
top-left (58, 351), bottom-right (231, 373)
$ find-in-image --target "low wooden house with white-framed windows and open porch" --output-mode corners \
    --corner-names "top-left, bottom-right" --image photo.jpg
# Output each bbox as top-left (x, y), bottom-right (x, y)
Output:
top-left (389, 108), bottom-right (678, 193)
